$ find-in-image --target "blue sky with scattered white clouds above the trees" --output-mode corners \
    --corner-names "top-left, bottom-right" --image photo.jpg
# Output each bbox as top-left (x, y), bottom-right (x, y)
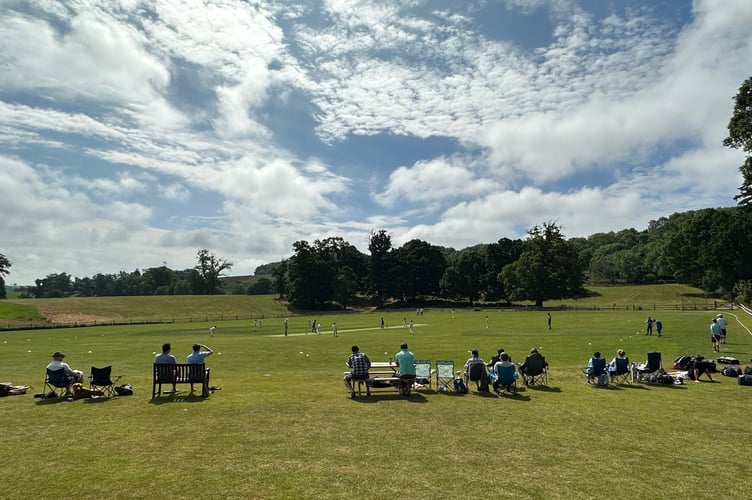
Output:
top-left (0, 0), bottom-right (752, 285)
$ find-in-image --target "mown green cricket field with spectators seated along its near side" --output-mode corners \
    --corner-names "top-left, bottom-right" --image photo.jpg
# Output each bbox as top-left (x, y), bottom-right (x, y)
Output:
top-left (0, 302), bottom-right (752, 499)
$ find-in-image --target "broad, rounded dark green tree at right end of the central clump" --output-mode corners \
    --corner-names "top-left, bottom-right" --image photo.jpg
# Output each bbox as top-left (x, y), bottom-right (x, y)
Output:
top-left (501, 222), bottom-right (585, 307)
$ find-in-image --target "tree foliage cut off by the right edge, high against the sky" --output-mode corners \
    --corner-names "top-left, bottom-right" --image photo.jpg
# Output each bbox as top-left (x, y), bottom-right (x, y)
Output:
top-left (723, 77), bottom-right (752, 206)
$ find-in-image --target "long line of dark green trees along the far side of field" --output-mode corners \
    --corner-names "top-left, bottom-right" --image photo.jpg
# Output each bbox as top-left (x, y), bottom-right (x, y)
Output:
top-left (0, 207), bottom-right (752, 309)
